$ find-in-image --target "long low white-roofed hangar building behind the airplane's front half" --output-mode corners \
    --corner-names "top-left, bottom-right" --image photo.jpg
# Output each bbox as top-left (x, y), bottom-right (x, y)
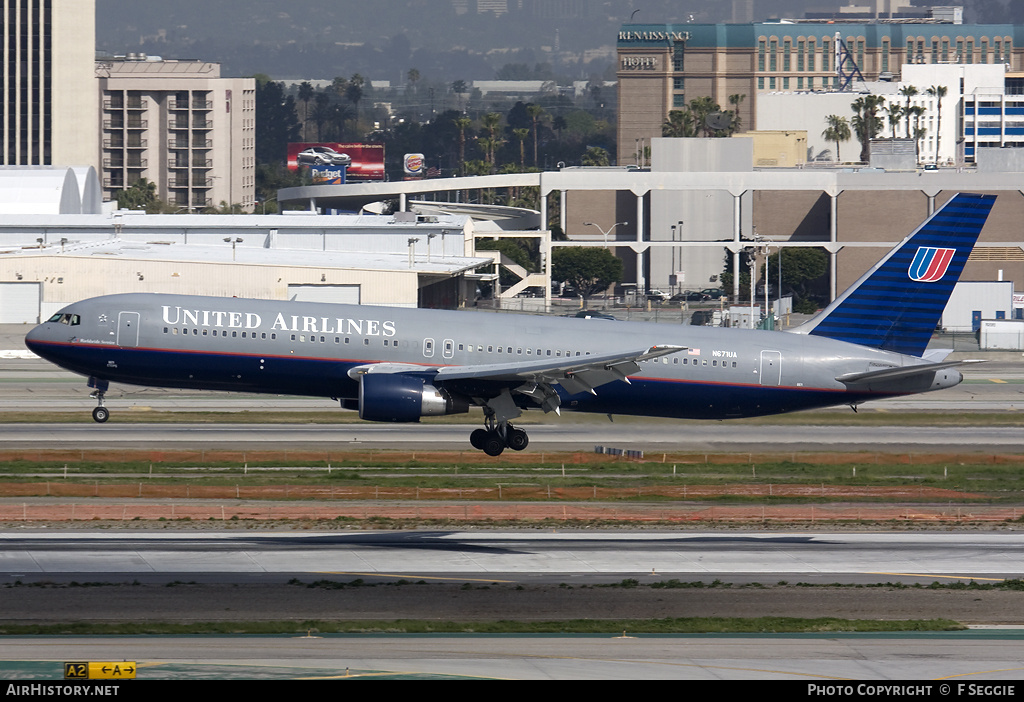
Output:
top-left (0, 207), bottom-right (493, 323)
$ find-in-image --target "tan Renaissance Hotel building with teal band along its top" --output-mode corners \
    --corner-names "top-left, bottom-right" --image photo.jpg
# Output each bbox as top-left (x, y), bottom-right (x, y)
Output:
top-left (617, 20), bottom-right (1024, 164)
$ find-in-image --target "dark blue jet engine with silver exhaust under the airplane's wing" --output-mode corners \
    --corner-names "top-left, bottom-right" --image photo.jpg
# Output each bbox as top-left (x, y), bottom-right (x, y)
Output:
top-left (359, 372), bottom-right (469, 422)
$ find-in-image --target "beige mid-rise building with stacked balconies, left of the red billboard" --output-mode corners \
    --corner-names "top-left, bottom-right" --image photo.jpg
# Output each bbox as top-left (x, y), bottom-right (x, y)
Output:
top-left (97, 54), bottom-right (256, 212)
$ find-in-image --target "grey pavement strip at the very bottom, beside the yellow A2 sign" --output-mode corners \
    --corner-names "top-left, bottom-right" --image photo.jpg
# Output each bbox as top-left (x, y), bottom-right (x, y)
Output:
top-left (6, 630), bottom-right (1024, 683)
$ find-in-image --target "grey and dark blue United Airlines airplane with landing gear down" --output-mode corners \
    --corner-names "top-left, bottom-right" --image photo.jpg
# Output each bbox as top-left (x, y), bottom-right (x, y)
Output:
top-left (26, 193), bottom-right (995, 456)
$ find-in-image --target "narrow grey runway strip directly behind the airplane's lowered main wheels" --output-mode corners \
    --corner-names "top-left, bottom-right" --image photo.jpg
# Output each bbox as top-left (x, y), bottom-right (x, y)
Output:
top-left (0, 418), bottom-right (1024, 454)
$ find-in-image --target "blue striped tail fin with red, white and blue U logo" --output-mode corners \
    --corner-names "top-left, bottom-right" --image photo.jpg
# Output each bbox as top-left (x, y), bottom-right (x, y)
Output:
top-left (794, 192), bottom-right (995, 356)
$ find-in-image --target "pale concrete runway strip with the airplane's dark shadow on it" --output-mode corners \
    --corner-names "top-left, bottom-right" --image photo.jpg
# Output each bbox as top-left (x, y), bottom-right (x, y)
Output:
top-left (0, 530), bottom-right (1024, 584)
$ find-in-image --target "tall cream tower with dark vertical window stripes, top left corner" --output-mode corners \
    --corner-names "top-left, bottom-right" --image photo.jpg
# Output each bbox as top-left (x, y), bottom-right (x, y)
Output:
top-left (0, 0), bottom-right (99, 166)
